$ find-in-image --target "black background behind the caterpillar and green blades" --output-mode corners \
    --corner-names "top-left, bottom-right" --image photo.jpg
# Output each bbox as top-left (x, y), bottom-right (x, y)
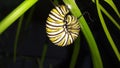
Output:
top-left (0, 0), bottom-right (120, 68)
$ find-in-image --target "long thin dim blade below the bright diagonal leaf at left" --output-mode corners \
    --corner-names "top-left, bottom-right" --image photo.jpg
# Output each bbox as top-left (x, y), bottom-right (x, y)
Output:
top-left (13, 15), bottom-right (24, 63)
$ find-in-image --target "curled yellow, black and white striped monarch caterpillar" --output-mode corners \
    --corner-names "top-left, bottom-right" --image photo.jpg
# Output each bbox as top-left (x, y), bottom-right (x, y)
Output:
top-left (46, 5), bottom-right (80, 46)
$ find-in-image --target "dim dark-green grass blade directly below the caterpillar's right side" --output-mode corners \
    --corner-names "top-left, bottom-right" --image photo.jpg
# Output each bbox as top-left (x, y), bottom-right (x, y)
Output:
top-left (69, 37), bottom-right (80, 68)
